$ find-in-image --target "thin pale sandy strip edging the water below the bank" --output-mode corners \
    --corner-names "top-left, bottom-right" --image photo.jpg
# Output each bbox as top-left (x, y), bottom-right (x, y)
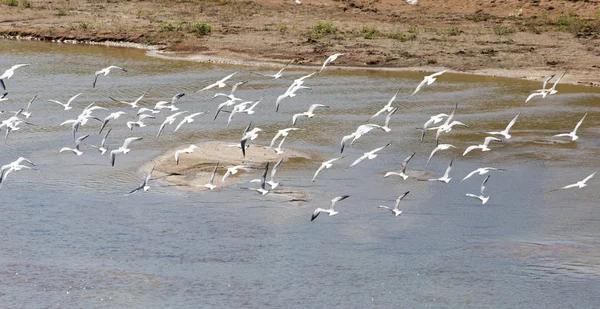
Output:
top-left (0, 35), bottom-right (600, 87)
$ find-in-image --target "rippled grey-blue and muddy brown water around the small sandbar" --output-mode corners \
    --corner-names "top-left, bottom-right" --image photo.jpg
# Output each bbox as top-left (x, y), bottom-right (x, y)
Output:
top-left (0, 41), bottom-right (600, 308)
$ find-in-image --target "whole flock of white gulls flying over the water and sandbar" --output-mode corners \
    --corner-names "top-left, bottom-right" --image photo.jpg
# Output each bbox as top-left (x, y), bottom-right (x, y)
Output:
top-left (0, 53), bottom-right (596, 221)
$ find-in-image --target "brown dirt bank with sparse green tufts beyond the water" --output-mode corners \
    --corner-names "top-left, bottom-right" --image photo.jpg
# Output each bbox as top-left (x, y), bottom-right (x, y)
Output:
top-left (0, 0), bottom-right (600, 85)
